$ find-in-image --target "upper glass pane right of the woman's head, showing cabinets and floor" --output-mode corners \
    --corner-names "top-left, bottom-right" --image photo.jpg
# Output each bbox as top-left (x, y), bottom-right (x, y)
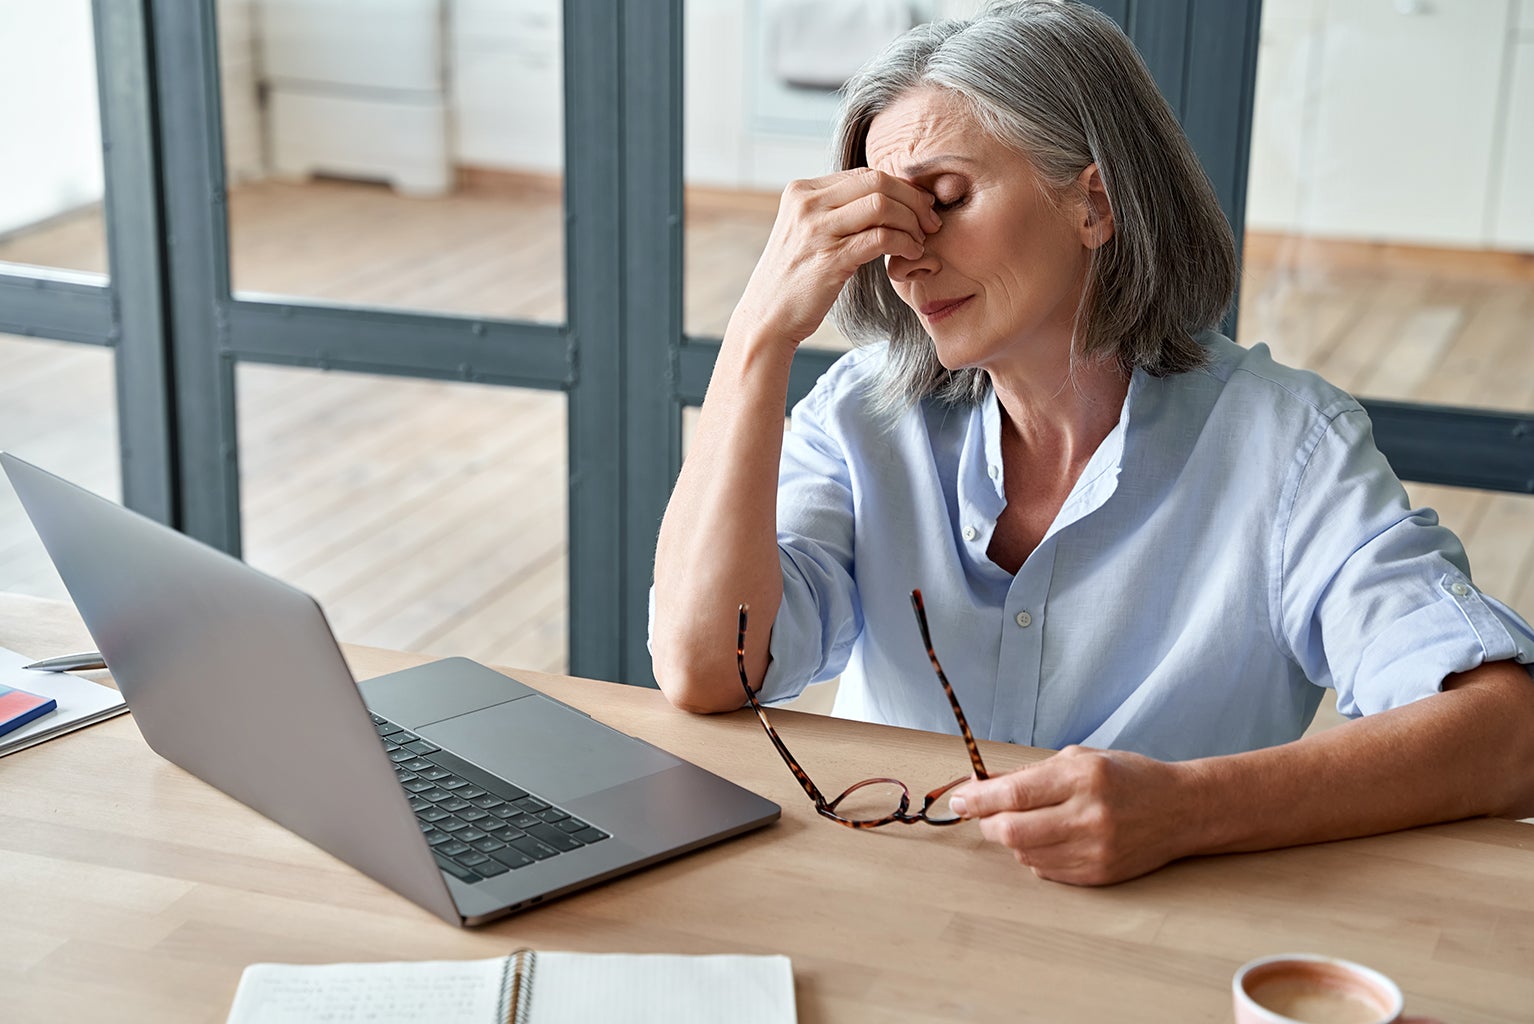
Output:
top-left (1239, 0), bottom-right (1534, 416)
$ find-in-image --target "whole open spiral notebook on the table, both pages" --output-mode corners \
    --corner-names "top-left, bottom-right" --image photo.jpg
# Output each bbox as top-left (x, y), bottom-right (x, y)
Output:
top-left (229, 949), bottom-right (798, 1024)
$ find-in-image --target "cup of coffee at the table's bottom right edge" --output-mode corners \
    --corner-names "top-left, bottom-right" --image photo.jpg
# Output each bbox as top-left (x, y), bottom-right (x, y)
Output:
top-left (1230, 953), bottom-right (1427, 1024)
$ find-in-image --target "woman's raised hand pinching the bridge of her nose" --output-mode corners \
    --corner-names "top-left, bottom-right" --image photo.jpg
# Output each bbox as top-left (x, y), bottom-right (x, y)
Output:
top-left (732, 167), bottom-right (942, 352)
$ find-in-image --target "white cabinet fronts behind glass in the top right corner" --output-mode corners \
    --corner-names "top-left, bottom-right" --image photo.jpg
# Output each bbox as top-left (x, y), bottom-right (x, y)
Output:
top-left (1247, 0), bottom-right (1534, 248)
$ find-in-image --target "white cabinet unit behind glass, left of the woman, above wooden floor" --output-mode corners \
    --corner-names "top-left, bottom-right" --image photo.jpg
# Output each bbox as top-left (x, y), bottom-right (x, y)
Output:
top-left (256, 0), bottom-right (453, 195)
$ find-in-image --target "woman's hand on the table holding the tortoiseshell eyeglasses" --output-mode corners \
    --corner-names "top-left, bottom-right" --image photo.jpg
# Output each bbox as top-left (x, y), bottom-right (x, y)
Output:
top-left (954, 747), bottom-right (1198, 886)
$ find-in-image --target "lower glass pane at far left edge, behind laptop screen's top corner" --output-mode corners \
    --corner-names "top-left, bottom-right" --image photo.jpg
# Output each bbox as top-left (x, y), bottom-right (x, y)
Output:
top-left (0, 334), bottom-right (123, 601)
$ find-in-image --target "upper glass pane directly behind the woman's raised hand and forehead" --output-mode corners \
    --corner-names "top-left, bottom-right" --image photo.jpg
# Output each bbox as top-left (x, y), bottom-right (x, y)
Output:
top-left (684, 0), bottom-right (982, 350)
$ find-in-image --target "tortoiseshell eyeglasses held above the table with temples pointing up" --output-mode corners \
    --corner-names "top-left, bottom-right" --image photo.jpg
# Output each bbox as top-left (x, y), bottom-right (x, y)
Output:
top-left (735, 590), bottom-right (989, 828)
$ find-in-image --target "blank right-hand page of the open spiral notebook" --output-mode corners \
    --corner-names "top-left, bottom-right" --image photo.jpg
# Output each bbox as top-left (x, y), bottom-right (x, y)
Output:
top-left (526, 952), bottom-right (798, 1024)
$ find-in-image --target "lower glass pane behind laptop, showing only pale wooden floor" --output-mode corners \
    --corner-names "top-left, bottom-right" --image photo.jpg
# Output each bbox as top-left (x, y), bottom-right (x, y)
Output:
top-left (236, 363), bottom-right (568, 671)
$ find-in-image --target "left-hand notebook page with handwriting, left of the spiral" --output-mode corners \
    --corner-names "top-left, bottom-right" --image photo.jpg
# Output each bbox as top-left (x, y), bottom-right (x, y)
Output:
top-left (229, 957), bottom-right (506, 1024)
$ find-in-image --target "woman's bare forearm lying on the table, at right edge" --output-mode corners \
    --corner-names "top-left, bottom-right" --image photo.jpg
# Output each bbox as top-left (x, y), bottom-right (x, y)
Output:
top-left (1183, 662), bottom-right (1534, 854)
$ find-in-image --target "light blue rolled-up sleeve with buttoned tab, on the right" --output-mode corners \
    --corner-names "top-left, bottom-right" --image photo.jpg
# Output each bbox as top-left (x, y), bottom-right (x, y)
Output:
top-left (1276, 405), bottom-right (1534, 717)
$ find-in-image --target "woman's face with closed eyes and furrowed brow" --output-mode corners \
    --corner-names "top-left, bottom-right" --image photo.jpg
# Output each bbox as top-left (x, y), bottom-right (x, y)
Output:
top-left (865, 89), bottom-right (1112, 377)
